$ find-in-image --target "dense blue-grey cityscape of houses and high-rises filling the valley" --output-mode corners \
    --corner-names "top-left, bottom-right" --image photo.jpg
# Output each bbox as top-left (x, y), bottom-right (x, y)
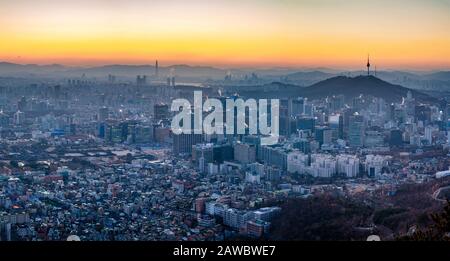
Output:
top-left (0, 61), bottom-right (450, 241)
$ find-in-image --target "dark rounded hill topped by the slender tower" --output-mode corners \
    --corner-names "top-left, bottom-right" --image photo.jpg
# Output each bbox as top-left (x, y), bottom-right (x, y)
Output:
top-left (238, 76), bottom-right (437, 102)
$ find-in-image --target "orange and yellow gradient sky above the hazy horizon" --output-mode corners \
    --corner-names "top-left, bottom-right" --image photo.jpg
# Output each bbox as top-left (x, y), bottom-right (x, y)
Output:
top-left (0, 0), bottom-right (450, 70)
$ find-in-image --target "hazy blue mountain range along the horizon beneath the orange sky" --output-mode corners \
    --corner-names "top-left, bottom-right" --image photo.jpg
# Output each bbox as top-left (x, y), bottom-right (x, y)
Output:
top-left (0, 62), bottom-right (450, 93)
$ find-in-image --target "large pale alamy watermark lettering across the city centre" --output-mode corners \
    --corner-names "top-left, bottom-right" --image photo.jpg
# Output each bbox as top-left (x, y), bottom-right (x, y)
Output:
top-left (171, 91), bottom-right (280, 145)
